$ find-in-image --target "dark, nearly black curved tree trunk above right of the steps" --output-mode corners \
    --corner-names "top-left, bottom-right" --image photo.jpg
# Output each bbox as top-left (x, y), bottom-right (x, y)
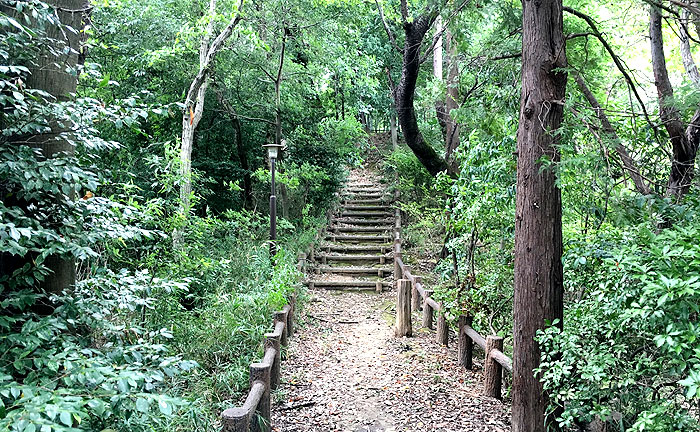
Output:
top-left (395, 15), bottom-right (447, 176)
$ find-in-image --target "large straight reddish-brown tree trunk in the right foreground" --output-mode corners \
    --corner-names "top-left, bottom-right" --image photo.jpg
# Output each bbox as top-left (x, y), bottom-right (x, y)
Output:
top-left (512, 0), bottom-right (566, 432)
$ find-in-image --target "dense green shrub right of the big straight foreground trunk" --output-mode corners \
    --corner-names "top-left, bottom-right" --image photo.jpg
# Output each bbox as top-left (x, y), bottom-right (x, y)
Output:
top-left (539, 211), bottom-right (700, 431)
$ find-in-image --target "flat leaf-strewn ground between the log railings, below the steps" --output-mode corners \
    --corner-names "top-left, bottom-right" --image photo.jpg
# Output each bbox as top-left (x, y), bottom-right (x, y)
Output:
top-left (272, 290), bottom-right (510, 432)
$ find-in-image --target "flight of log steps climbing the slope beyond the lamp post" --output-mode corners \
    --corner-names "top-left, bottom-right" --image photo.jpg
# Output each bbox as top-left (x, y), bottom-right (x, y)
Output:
top-left (307, 176), bottom-right (394, 292)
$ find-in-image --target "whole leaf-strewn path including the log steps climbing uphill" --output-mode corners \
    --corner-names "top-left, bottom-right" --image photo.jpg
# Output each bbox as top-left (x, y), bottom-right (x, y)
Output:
top-left (272, 170), bottom-right (510, 432)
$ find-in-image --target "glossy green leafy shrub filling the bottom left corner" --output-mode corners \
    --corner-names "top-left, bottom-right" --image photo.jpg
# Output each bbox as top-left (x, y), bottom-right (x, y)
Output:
top-left (0, 270), bottom-right (196, 431)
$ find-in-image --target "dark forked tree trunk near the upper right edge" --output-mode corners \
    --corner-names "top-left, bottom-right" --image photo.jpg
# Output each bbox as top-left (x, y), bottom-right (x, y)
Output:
top-left (649, 6), bottom-right (700, 200)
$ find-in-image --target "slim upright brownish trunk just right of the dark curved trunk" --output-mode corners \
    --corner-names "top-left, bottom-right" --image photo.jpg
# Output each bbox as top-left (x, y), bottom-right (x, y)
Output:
top-left (445, 30), bottom-right (459, 175)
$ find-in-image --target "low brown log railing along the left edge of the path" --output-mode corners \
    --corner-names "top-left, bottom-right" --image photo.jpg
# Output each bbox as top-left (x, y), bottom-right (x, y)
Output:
top-left (221, 253), bottom-right (304, 432)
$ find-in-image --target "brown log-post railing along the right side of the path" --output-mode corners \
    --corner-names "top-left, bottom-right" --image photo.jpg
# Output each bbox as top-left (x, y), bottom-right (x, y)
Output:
top-left (393, 191), bottom-right (513, 399)
